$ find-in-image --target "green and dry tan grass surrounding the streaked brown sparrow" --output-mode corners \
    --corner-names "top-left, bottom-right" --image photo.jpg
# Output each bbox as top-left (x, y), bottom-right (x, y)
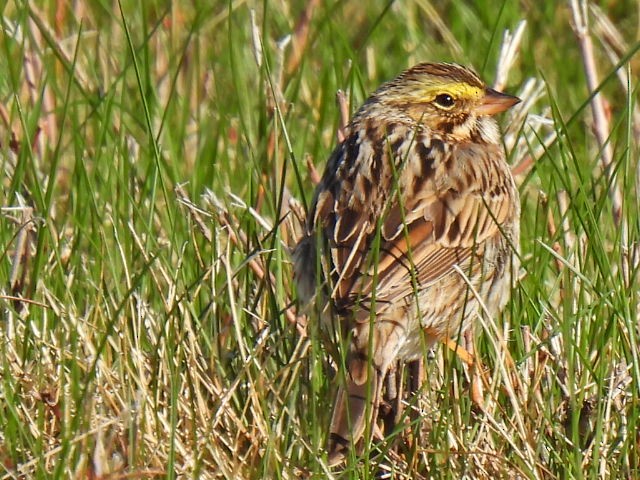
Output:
top-left (0, 0), bottom-right (640, 479)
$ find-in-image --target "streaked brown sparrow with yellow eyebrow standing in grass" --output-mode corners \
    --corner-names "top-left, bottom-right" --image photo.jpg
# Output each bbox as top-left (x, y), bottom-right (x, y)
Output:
top-left (293, 63), bottom-right (520, 464)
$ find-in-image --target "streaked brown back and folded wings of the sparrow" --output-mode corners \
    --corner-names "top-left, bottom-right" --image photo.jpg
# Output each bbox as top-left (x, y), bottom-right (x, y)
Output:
top-left (312, 131), bottom-right (517, 309)
